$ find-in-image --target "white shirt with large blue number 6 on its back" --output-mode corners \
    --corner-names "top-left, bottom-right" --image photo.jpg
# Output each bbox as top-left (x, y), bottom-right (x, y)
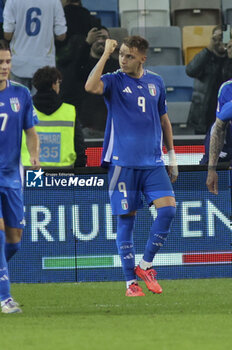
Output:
top-left (3, 0), bottom-right (67, 90)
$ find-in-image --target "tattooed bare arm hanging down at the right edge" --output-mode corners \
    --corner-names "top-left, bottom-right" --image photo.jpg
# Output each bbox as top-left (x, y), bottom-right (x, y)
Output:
top-left (206, 118), bottom-right (227, 194)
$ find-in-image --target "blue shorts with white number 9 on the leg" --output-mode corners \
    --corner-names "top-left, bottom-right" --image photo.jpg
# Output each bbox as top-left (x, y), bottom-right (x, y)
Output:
top-left (108, 166), bottom-right (175, 215)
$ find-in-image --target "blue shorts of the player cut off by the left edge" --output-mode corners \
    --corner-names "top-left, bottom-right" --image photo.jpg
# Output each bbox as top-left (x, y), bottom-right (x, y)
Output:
top-left (0, 187), bottom-right (24, 228)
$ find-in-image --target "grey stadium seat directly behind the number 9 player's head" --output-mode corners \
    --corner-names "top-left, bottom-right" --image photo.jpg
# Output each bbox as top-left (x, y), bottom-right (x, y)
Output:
top-left (131, 26), bottom-right (183, 66)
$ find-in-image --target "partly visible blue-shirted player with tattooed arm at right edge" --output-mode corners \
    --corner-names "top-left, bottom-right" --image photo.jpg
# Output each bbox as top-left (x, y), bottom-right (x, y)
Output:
top-left (206, 79), bottom-right (232, 194)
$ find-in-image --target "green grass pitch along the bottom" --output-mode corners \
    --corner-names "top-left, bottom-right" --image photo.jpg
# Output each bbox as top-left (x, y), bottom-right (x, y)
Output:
top-left (0, 279), bottom-right (232, 350)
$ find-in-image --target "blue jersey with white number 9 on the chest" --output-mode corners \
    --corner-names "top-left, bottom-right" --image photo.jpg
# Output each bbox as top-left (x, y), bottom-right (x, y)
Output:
top-left (101, 69), bottom-right (167, 168)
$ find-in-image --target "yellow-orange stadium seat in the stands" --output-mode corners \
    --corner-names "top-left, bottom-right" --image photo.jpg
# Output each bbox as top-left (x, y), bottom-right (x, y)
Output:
top-left (182, 25), bottom-right (215, 64)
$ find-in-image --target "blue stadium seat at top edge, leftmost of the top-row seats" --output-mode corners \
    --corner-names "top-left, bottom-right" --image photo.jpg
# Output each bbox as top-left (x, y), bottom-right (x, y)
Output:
top-left (82, 0), bottom-right (119, 27)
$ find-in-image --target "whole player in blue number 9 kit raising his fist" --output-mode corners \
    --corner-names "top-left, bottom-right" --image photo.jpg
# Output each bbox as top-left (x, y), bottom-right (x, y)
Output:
top-left (85, 36), bottom-right (178, 296)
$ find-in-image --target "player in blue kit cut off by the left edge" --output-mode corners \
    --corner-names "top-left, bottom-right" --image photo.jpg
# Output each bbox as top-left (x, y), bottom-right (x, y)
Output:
top-left (0, 40), bottom-right (39, 313)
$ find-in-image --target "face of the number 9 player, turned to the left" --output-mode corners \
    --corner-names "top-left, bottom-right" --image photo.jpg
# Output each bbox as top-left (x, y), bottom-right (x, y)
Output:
top-left (119, 44), bottom-right (146, 77)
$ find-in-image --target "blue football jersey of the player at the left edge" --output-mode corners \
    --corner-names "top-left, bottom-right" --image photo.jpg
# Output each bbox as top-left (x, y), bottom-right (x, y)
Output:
top-left (0, 81), bottom-right (38, 188)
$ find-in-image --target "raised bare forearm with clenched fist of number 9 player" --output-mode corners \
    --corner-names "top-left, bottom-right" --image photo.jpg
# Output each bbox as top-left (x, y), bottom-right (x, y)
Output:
top-left (85, 39), bottom-right (118, 95)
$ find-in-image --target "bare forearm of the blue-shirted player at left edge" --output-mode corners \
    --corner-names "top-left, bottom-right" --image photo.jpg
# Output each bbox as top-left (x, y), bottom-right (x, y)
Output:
top-left (25, 127), bottom-right (40, 169)
